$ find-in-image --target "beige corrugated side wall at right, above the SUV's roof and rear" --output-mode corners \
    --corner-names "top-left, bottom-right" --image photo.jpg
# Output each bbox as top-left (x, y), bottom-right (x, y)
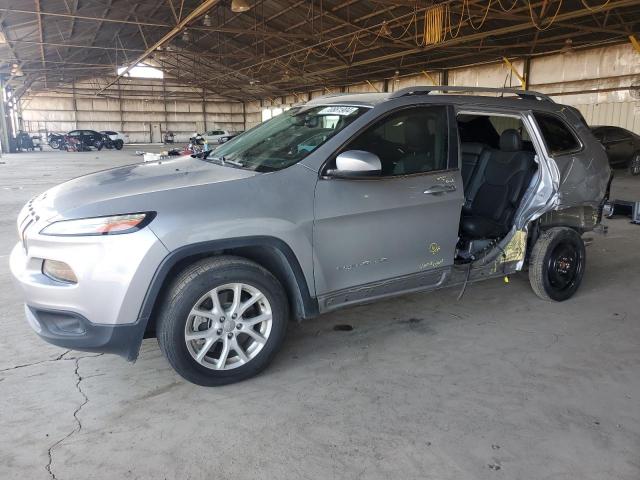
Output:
top-left (282, 44), bottom-right (640, 134)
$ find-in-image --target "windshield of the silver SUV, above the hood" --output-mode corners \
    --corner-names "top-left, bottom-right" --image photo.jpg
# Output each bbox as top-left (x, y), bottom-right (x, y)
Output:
top-left (209, 105), bottom-right (367, 172)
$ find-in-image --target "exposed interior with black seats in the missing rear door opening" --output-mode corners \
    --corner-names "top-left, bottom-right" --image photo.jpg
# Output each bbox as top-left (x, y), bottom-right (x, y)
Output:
top-left (456, 114), bottom-right (537, 263)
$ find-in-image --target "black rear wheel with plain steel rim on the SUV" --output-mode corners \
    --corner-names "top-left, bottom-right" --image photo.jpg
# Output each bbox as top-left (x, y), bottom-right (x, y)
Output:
top-left (529, 227), bottom-right (586, 302)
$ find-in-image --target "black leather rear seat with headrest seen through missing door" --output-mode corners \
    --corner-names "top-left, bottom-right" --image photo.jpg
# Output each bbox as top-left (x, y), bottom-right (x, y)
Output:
top-left (461, 129), bottom-right (535, 239)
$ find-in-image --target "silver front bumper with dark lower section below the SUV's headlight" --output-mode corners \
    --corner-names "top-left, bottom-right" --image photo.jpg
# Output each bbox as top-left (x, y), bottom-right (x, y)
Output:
top-left (10, 226), bottom-right (168, 360)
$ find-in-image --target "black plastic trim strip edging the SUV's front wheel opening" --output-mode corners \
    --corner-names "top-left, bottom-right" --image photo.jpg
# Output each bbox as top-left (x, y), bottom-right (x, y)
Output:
top-left (128, 236), bottom-right (319, 360)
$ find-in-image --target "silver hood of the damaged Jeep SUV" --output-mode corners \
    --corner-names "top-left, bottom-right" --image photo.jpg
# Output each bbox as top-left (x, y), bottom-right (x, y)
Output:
top-left (33, 156), bottom-right (260, 219)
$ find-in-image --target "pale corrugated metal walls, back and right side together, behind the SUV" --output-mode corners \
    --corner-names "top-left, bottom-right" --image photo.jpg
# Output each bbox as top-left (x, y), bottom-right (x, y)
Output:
top-left (23, 44), bottom-right (640, 137)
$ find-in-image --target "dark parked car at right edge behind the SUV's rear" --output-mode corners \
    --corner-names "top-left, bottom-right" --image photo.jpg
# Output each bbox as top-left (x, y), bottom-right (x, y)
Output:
top-left (591, 126), bottom-right (640, 175)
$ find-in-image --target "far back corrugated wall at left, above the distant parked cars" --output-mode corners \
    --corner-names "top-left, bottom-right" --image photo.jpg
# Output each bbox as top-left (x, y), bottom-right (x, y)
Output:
top-left (22, 79), bottom-right (245, 143)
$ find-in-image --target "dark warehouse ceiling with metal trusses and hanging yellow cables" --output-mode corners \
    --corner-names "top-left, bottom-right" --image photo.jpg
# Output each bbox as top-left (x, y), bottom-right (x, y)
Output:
top-left (0, 0), bottom-right (640, 99)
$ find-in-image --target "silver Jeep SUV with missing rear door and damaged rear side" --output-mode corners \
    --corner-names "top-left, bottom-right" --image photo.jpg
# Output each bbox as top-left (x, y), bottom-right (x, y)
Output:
top-left (11, 87), bottom-right (610, 386)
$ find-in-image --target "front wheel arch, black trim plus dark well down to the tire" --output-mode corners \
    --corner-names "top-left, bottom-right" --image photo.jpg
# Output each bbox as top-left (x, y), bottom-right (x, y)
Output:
top-left (138, 236), bottom-right (319, 341)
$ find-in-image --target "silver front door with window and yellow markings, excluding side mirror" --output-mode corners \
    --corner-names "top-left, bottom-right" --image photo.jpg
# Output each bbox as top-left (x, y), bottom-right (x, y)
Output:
top-left (313, 106), bottom-right (464, 309)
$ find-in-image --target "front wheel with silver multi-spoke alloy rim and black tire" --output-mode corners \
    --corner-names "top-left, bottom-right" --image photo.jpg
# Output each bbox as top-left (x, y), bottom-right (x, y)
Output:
top-left (156, 256), bottom-right (289, 387)
